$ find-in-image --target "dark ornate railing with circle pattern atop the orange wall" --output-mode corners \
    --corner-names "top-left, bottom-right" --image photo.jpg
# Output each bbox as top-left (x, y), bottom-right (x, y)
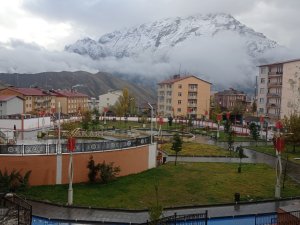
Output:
top-left (0, 137), bottom-right (151, 155)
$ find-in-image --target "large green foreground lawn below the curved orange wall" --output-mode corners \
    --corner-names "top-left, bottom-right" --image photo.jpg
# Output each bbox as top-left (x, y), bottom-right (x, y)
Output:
top-left (20, 163), bottom-right (300, 209)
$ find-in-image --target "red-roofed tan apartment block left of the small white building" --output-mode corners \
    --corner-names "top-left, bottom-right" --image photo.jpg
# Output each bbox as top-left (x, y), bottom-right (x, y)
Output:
top-left (50, 90), bottom-right (89, 115)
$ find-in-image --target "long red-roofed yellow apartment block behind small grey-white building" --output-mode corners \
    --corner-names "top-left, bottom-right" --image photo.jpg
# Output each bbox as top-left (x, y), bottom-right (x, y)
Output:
top-left (0, 87), bottom-right (55, 114)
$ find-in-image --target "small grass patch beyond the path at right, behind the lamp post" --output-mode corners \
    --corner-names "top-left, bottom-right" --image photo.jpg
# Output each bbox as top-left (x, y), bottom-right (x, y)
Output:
top-left (247, 145), bottom-right (300, 164)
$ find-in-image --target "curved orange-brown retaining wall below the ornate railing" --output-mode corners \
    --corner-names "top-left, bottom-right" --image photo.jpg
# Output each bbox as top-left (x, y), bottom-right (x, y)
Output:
top-left (0, 145), bottom-right (150, 185)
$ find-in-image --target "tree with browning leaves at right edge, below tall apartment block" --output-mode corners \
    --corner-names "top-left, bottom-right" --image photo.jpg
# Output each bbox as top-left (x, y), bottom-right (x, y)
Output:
top-left (283, 113), bottom-right (300, 152)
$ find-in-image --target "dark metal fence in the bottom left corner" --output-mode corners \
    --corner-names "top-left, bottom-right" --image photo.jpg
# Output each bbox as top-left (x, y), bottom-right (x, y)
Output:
top-left (0, 194), bottom-right (32, 225)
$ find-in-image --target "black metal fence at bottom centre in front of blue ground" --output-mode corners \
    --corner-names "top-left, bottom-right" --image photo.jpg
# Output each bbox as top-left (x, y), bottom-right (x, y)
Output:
top-left (144, 211), bottom-right (208, 225)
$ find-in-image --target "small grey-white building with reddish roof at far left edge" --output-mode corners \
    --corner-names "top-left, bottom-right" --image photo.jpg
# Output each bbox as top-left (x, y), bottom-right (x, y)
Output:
top-left (0, 95), bottom-right (24, 116)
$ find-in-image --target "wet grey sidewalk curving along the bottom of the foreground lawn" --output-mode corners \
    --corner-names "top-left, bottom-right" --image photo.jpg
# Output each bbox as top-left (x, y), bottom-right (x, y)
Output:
top-left (29, 200), bottom-right (300, 224)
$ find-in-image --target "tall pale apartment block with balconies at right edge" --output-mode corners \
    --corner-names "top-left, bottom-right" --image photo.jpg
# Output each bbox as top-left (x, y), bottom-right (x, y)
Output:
top-left (256, 59), bottom-right (300, 120)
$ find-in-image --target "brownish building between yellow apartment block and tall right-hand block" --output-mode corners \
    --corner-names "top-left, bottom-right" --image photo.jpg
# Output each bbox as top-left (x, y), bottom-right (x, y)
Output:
top-left (214, 88), bottom-right (247, 110)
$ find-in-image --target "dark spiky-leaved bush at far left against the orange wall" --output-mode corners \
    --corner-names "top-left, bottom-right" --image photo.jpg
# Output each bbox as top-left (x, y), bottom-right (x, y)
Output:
top-left (0, 169), bottom-right (31, 192)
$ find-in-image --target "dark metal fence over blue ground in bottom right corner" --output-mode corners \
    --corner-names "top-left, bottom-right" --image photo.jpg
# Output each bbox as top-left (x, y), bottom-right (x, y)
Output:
top-left (255, 211), bottom-right (300, 225)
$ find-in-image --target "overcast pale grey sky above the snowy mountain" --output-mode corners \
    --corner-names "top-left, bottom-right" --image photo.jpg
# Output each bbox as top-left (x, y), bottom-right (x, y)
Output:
top-left (0, 0), bottom-right (300, 50)
